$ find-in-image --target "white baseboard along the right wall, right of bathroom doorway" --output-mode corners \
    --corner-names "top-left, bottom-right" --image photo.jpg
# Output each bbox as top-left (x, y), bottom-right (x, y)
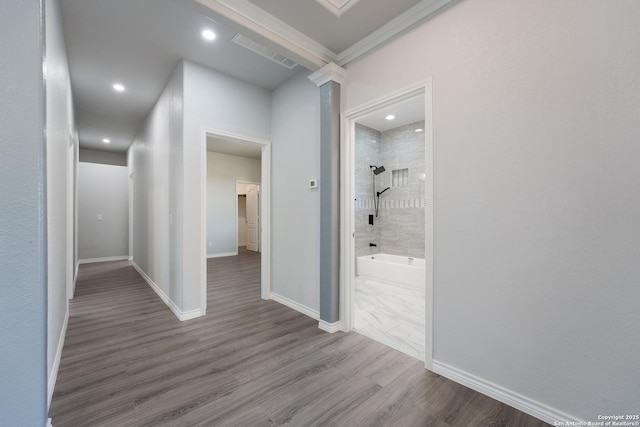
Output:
top-left (433, 360), bottom-right (586, 425)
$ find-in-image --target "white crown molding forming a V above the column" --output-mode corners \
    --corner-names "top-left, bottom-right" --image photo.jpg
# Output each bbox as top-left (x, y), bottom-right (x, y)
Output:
top-left (188, 0), bottom-right (458, 67)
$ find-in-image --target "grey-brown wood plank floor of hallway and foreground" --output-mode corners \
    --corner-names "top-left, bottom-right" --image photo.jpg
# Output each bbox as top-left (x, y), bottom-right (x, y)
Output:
top-left (49, 247), bottom-right (547, 427)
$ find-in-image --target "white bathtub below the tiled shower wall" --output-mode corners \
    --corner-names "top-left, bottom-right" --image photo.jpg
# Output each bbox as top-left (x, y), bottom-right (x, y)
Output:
top-left (356, 254), bottom-right (425, 292)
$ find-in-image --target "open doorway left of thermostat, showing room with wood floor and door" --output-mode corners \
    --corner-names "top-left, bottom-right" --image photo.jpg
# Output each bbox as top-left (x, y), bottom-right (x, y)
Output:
top-left (202, 130), bottom-right (271, 312)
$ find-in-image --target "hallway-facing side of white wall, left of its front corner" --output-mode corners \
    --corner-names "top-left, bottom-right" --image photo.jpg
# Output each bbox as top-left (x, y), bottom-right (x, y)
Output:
top-left (127, 65), bottom-right (183, 309)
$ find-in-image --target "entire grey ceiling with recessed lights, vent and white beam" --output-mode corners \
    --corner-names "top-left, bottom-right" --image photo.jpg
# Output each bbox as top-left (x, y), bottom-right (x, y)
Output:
top-left (60, 0), bottom-right (452, 152)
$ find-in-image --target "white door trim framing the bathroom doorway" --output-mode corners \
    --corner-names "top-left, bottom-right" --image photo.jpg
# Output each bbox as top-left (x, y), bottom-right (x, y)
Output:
top-left (340, 78), bottom-right (435, 371)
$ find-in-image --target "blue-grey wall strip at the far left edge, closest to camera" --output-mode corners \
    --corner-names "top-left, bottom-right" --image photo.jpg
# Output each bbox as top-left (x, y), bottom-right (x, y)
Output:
top-left (0, 1), bottom-right (47, 427)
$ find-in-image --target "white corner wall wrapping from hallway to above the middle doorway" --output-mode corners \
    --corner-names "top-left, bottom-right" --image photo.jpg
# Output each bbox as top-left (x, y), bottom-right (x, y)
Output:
top-left (127, 62), bottom-right (271, 318)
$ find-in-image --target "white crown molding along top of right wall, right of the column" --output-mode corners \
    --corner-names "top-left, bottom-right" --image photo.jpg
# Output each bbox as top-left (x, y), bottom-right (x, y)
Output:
top-left (337, 0), bottom-right (456, 66)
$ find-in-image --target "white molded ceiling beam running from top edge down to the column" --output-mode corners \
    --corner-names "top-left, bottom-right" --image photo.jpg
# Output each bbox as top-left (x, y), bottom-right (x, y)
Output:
top-left (194, 0), bottom-right (337, 70)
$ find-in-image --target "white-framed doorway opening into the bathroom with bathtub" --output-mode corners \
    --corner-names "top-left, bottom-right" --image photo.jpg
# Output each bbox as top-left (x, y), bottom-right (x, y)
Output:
top-left (340, 80), bottom-right (434, 369)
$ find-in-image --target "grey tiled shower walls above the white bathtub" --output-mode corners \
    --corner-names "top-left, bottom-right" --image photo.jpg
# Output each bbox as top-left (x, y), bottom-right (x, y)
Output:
top-left (355, 122), bottom-right (425, 258)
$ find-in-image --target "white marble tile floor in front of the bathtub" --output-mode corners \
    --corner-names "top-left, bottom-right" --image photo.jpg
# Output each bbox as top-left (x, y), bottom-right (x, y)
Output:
top-left (354, 276), bottom-right (425, 361)
